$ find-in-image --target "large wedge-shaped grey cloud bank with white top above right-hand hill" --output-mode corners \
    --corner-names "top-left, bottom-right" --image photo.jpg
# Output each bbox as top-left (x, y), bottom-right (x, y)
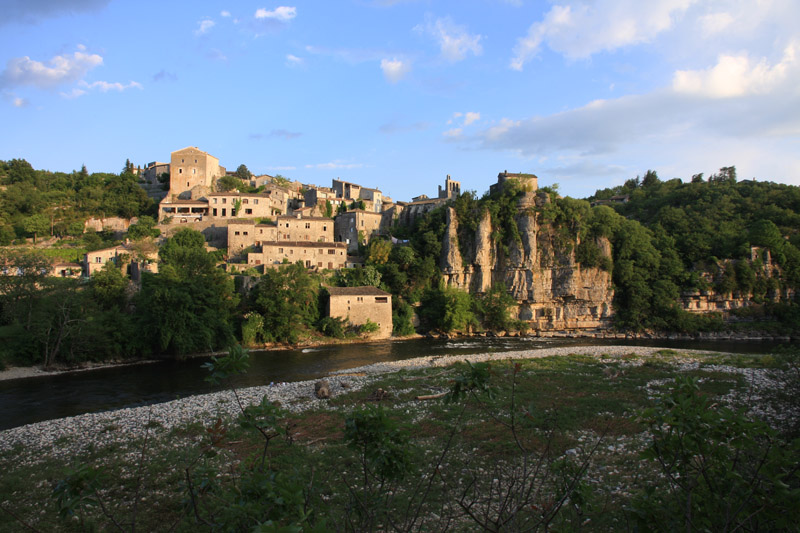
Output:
top-left (468, 39), bottom-right (800, 195)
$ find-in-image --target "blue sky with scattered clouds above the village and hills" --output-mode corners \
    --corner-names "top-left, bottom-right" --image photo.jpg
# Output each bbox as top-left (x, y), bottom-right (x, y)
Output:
top-left (0, 0), bottom-right (800, 200)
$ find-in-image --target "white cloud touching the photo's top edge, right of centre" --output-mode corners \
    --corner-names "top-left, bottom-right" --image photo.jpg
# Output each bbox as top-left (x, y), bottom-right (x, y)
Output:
top-left (510, 0), bottom-right (697, 70)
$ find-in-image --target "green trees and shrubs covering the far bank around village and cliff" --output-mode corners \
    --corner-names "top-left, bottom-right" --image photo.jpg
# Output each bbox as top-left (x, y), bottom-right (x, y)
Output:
top-left (0, 160), bottom-right (800, 367)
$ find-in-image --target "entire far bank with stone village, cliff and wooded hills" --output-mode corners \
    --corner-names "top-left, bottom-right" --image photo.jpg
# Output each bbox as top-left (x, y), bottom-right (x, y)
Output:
top-left (0, 147), bottom-right (800, 363)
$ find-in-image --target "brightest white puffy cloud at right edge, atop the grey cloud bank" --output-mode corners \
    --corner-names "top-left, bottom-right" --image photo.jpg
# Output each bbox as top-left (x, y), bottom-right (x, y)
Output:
top-left (672, 43), bottom-right (800, 98)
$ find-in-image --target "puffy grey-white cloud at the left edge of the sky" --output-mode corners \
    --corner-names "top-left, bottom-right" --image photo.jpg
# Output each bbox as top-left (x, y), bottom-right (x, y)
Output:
top-left (0, 51), bottom-right (103, 89)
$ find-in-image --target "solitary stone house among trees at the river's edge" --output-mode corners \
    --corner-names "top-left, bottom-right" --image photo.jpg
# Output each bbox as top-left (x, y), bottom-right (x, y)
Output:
top-left (328, 287), bottom-right (392, 339)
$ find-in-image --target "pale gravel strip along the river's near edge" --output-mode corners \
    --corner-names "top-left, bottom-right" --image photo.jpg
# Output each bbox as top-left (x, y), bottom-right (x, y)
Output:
top-left (0, 346), bottom-right (776, 462)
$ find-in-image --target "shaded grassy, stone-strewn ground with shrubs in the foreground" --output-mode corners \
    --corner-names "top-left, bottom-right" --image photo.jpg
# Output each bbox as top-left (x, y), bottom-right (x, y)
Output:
top-left (0, 350), bottom-right (800, 531)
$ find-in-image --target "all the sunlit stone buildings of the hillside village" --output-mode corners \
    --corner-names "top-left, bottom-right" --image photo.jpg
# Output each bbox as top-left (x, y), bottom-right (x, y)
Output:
top-left (79, 147), bottom-right (537, 338)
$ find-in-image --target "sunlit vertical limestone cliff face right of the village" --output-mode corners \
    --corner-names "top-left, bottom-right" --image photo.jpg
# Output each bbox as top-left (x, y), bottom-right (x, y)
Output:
top-left (441, 204), bottom-right (614, 332)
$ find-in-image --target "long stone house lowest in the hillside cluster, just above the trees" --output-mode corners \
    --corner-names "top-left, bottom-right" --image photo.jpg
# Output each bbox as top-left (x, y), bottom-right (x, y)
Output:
top-left (247, 241), bottom-right (347, 270)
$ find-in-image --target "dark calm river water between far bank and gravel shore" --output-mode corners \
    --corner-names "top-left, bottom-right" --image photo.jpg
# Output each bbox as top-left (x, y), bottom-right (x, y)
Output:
top-left (0, 338), bottom-right (792, 429)
